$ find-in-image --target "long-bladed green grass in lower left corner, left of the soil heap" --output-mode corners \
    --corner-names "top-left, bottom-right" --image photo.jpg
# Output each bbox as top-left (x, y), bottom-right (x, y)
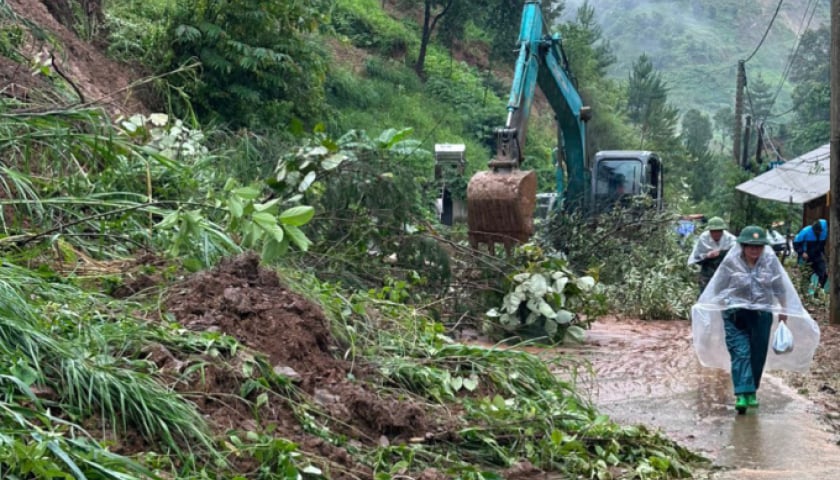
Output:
top-left (0, 260), bottom-right (220, 472)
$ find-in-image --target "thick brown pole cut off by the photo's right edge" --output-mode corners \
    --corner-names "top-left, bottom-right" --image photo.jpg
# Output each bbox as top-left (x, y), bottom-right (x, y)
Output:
top-left (828, 0), bottom-right (840, 325)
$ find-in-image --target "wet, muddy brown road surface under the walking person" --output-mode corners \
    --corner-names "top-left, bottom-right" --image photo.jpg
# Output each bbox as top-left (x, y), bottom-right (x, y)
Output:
top-left (569, 319), bottom-right (840, 480)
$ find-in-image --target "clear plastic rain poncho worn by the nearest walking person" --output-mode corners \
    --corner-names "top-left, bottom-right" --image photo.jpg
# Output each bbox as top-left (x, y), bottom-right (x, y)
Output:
top-left (691, 243), bottom-right (820, 372)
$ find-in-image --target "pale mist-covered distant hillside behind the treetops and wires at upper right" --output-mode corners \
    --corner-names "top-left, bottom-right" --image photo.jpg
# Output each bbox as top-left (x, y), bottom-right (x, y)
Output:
top-left (563, 0), bottom-right (830, 119)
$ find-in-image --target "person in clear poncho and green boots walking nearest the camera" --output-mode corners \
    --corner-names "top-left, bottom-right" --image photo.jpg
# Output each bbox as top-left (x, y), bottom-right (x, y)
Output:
top-left (691, 225), bottom-right (820, 413)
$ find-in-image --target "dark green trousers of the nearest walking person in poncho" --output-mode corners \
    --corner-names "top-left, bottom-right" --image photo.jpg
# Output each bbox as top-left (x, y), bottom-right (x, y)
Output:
top-left (723, 308), bottom-right (773, 395)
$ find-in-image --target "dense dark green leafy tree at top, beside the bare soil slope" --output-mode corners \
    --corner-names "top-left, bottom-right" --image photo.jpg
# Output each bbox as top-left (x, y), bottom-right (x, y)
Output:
top-left (160, 0), bottom-right (327, 131)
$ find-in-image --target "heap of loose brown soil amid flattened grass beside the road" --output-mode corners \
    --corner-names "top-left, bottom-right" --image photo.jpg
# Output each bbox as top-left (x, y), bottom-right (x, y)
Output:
top-left (162, 254), bottom-right (436, 477)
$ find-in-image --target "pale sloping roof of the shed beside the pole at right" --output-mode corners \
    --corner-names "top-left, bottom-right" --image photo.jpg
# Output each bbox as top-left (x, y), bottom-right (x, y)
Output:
top-left (735, 144), bottom-right (831, 203)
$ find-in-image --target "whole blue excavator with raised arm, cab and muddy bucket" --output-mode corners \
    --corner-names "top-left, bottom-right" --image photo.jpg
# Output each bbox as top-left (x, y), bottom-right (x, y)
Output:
top-left (467, 0), bottom-right (662, 253)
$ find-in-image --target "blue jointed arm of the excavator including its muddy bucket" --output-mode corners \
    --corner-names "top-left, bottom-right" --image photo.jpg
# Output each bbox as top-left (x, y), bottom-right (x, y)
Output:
top-left (467, 0), bottom-right (590, 251)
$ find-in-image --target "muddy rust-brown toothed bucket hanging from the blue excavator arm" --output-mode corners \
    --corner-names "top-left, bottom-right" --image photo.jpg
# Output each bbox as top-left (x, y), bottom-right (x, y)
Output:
top-left (467, 169), bottom-right (537, 254)
